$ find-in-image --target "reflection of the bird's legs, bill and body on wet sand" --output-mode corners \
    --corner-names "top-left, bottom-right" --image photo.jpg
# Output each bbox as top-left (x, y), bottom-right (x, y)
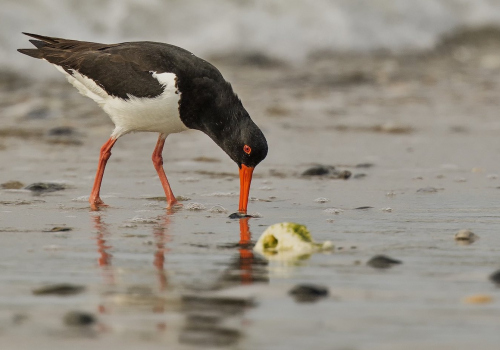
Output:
top-left (93, 212), bottom-right (269, 347)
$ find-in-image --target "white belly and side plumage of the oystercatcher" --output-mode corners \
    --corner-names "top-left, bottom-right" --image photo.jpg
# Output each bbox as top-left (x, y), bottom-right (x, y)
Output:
top-left (54, 65), bottom-right (188, 138)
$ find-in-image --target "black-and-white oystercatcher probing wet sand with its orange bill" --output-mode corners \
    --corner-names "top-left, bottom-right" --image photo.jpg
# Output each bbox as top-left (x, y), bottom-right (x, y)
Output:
top-left (18, 33), bottom-right (267, 213)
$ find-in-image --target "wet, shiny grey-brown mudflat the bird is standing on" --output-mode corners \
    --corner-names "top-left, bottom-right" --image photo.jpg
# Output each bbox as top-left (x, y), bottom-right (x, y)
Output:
top-left (0, 34), bottom-right (500, 349)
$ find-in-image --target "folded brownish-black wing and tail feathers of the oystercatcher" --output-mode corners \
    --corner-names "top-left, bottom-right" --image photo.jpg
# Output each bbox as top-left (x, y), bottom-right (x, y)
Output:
top-left (18, 33), bottom-right (222, 99)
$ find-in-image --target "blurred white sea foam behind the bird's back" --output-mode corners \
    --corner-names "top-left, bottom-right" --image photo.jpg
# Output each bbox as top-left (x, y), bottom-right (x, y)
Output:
top-left (5, 0), bottom-right (500, 76)
